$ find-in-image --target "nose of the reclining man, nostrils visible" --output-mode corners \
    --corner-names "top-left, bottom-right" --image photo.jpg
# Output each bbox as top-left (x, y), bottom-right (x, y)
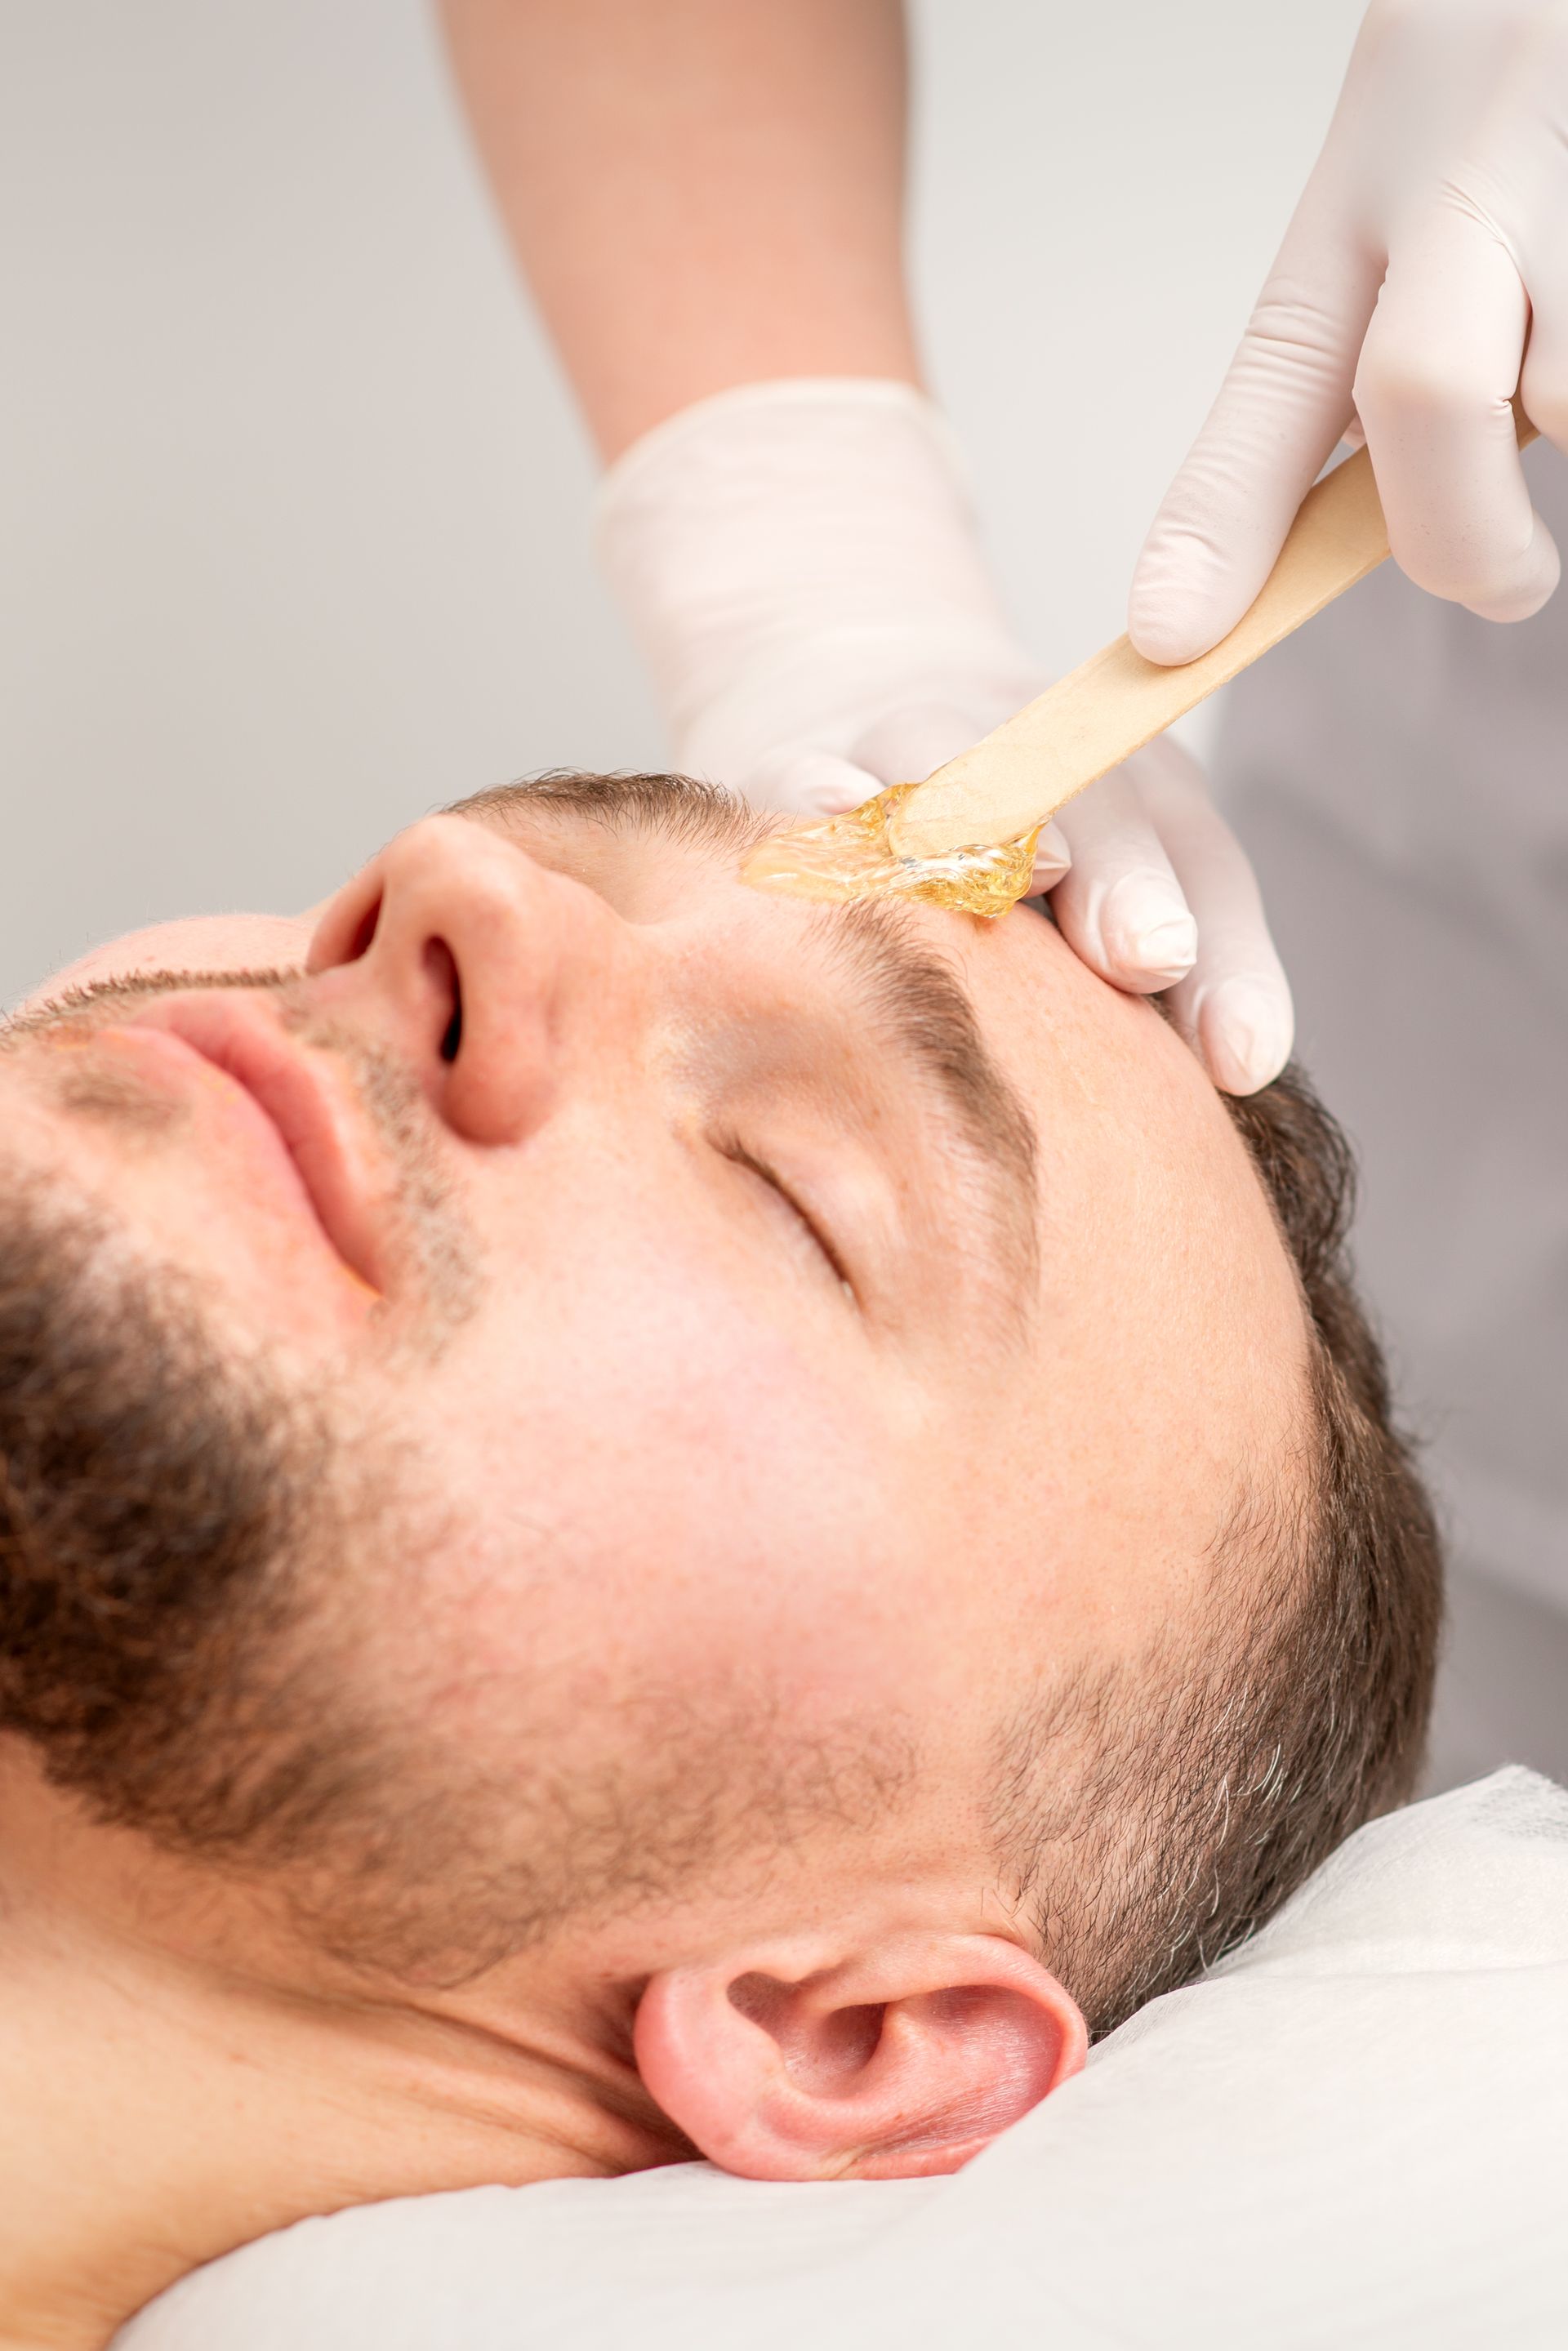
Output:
top-left (305, 816), bottom-right (626, 1142)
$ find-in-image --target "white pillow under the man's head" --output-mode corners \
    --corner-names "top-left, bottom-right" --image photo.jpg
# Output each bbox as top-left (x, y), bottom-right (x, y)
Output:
top-left (115, 1770), bottom-right (1568, 2351)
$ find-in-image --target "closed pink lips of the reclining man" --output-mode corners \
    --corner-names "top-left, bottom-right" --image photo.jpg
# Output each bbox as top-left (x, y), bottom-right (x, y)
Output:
top-left (125, 990), bottom-right (388, 1293)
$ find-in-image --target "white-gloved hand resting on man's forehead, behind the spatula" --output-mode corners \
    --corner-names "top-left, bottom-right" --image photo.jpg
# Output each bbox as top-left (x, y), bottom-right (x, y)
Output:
top-left (597, 381), bottom-right (1290, 1093)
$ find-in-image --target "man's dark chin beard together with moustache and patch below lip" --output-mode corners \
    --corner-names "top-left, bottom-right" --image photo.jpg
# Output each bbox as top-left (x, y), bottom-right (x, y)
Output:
top-left (0, 971), bottom-right (477, 1867)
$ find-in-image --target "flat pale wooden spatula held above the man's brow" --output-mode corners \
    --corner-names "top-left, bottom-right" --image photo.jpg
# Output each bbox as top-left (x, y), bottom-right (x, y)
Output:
top-left (886, 402), bottom-right (1535, 858)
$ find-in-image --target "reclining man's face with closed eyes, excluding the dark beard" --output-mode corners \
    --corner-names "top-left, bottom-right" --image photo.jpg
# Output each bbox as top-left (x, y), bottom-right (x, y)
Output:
top-left (0, 792), bottom-right (1305, 1975)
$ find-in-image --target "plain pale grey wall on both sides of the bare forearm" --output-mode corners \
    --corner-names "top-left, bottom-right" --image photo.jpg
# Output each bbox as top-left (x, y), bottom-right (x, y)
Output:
top-left (0, 0), bottom-right (1361, 1000)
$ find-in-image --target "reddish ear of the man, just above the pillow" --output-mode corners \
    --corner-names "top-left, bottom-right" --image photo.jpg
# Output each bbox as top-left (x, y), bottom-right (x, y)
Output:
top-left (635, 1935), bottom-right (1089, 2180)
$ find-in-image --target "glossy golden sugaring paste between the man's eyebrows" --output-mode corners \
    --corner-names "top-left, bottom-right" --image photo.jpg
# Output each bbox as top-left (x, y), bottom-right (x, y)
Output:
top-left (741, 783), bottom-right (1039, 915)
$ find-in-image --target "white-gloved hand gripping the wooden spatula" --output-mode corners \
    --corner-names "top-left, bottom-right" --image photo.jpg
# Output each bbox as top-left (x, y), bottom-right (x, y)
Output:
top-left (1129, 0), bottom-right (1568, 661)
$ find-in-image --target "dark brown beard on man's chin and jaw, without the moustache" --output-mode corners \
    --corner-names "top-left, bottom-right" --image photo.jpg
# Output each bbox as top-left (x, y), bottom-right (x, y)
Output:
top-left (0, 1175), bottom-right (523, 1982)
